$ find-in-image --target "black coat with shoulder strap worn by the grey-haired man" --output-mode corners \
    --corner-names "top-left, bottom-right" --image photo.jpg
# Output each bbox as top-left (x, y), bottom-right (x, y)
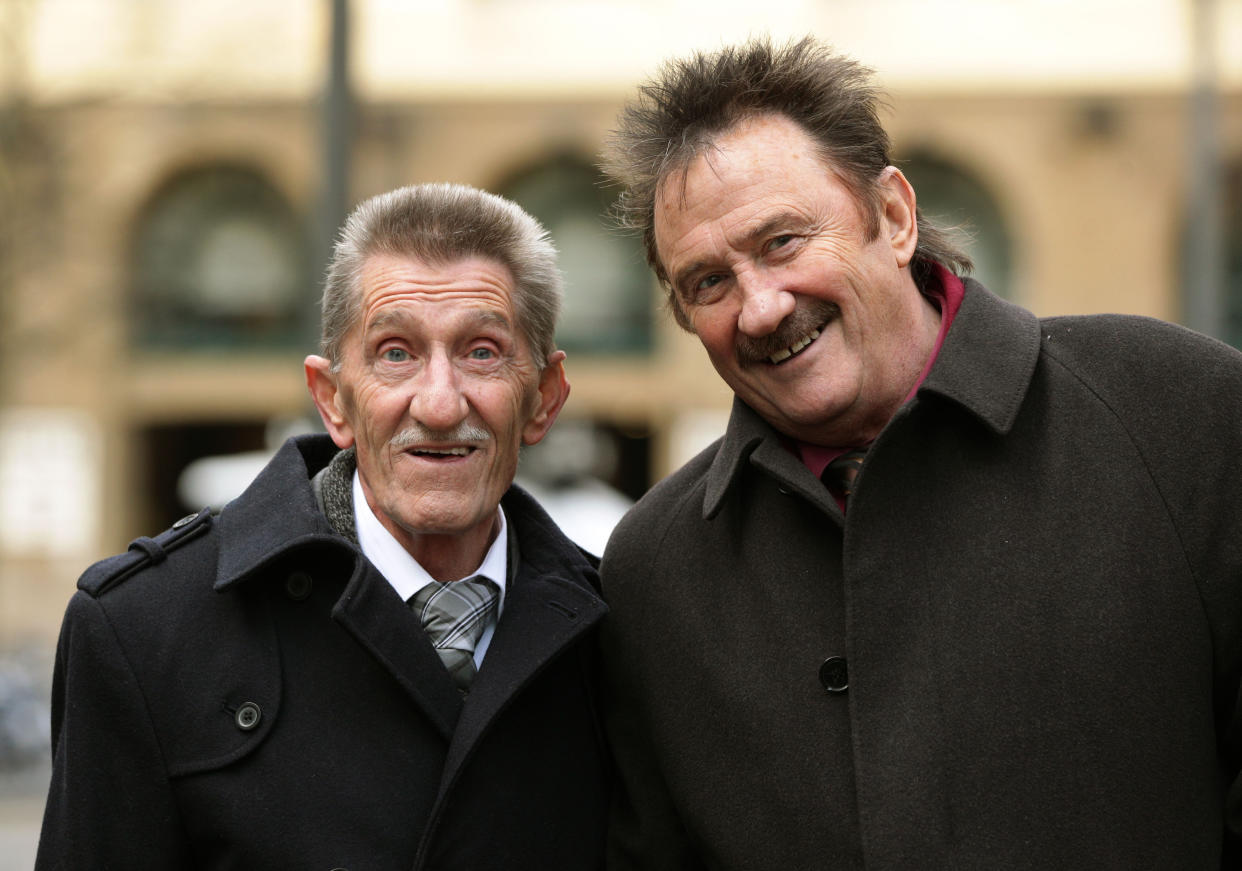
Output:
top-left (36, 436), bottom-right (607, 871)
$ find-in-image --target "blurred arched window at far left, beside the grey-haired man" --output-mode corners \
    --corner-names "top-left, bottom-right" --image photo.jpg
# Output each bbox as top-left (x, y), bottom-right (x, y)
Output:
top-left (133, 166), bottom-right (314, 347)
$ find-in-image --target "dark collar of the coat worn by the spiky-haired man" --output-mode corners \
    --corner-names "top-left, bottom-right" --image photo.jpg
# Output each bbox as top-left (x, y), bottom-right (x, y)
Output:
top-left (703, 278), bottom-right (1040, 518)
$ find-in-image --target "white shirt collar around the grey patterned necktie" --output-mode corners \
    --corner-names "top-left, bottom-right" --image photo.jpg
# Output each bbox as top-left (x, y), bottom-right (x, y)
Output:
top-left (354, 470), bottom-right (509, 668)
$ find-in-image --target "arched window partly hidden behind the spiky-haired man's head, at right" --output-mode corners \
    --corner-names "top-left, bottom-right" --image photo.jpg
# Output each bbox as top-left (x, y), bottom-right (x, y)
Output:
top-left (902, 154), bottom-right (1013, 298)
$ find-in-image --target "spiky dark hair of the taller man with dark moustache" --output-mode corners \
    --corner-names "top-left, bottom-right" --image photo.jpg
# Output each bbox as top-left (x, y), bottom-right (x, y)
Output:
top-left (604, 36), bottom-right (972, 329)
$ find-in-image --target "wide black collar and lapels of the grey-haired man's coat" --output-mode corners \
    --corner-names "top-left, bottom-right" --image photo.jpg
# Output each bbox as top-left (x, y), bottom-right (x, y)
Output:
top-left (215, 435), bottom-right (607, 745)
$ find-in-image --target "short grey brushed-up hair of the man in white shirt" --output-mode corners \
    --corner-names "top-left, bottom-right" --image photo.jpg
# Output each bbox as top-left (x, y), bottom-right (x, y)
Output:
top-left (320, 184), bottom-right (563, 370)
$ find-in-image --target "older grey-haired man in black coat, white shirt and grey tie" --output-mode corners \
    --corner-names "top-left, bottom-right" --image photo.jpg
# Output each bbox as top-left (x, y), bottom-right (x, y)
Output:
top-left (37, 185), bottom-right (607, 871)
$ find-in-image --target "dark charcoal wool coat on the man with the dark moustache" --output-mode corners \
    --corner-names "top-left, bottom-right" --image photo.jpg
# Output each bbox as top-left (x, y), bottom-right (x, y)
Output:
top-left (601, 282), bottom-right (1242, 871)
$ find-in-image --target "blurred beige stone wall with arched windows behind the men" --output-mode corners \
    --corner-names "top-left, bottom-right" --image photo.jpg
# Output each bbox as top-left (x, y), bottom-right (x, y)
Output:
top-left (0, 85), bottom-right (1242, 642)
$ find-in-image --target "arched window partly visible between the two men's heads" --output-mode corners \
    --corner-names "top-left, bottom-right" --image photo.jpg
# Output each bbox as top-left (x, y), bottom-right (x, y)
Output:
top-left (501, 158), bottom-right (652, 353)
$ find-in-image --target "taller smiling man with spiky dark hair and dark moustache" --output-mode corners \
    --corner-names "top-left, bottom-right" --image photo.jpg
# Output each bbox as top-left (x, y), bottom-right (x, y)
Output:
top-left (601, 39), bottom-right (1242, 871)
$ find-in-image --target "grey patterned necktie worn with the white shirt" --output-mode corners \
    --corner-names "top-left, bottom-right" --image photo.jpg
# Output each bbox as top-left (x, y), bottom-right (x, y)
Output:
top-left (410, 575), bottom-right (501, 691)
